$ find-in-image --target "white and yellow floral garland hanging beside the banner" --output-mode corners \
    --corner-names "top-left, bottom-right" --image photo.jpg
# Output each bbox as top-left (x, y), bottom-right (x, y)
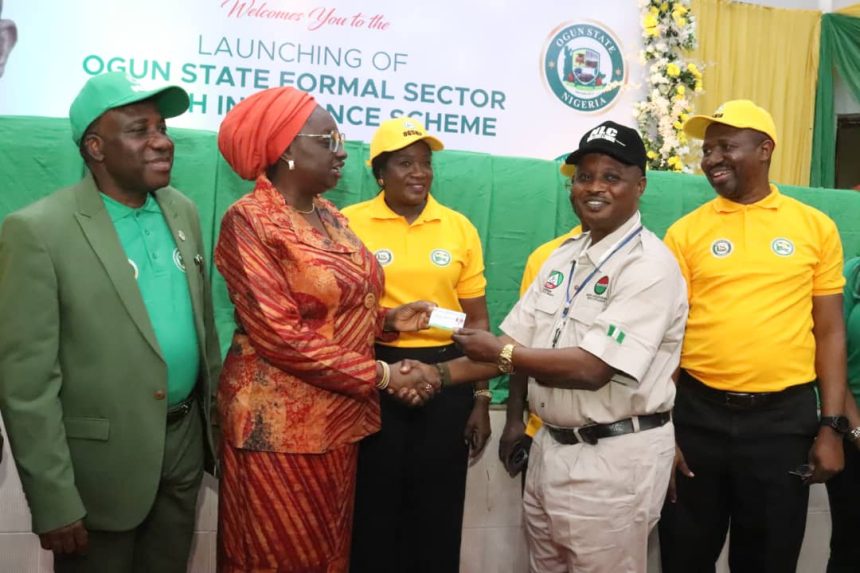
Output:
top-left (635, 0), bottom-right (702, 172)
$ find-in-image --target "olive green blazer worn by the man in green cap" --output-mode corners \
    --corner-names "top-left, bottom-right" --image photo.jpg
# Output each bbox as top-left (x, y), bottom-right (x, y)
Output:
top-left (0, 174), bottom-right (221, 533)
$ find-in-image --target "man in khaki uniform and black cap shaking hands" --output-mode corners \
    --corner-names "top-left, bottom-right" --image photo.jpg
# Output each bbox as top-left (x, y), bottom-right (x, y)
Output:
top-left (400, 118), bottom-right (687, 573)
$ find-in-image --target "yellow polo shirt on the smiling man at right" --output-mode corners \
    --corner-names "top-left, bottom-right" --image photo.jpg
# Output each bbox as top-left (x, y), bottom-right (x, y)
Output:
top-left (665, 185), bottom-right (845, 392)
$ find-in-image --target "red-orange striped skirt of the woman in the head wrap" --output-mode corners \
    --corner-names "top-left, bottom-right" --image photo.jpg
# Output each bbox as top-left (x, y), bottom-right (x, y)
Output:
top-left (218, 444), bottom-right (358, 573)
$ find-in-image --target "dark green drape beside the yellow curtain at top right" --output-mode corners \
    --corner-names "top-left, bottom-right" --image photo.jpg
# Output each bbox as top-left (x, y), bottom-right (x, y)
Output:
top-left (808, 14), bottom-right (860, 187)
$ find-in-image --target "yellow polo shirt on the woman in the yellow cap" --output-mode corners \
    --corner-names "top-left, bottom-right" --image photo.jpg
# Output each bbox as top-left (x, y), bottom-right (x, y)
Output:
top-left (342, 193), bottom-right (487, 348)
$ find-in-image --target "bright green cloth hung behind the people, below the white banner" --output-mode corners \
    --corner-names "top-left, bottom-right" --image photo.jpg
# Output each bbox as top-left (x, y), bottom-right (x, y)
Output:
top-left (5, 117), bottom-right (860, 402)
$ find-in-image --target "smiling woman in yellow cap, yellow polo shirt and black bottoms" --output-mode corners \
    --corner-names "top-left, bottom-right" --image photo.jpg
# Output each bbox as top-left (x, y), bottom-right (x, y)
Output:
top-left (343, 117), bottom-right (490, 573)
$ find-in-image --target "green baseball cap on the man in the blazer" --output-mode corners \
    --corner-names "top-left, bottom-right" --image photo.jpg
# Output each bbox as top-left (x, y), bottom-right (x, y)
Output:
top-left (69, 72), bottom-right (190, 145)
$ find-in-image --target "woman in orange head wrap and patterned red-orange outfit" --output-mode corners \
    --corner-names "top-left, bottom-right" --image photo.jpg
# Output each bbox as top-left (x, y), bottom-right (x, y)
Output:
top-left (215, 88), bottom-right (432, 573)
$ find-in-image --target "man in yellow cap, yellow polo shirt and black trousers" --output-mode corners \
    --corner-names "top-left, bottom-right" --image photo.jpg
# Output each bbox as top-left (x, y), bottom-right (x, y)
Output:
top-left (660, 100), bottom-right (847, 573)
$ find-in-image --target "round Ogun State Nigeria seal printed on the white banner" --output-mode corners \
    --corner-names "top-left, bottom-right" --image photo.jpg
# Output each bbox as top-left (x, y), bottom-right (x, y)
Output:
top-left (543, 22), bottom-right (627, 112)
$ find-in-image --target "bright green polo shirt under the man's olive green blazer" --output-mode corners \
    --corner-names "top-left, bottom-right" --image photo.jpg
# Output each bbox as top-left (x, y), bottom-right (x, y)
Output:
top-left (101, 193), bottom-right (200, 406)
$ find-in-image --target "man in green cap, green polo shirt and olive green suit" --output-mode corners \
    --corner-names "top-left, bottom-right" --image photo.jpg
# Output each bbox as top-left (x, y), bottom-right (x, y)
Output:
top-left (0, 73), bottom-right (221, 573)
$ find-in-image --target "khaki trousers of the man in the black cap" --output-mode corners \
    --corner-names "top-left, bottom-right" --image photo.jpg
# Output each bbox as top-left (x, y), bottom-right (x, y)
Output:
top-left (523, 422), bottom-right (675, 573)
